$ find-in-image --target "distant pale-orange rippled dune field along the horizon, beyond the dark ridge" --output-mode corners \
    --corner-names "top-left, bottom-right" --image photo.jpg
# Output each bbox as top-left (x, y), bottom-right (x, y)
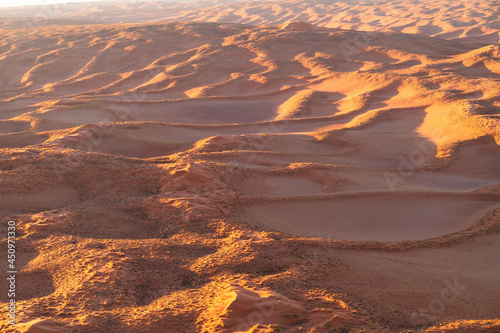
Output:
top-left (0, 0), bottom-right (500, 44)
